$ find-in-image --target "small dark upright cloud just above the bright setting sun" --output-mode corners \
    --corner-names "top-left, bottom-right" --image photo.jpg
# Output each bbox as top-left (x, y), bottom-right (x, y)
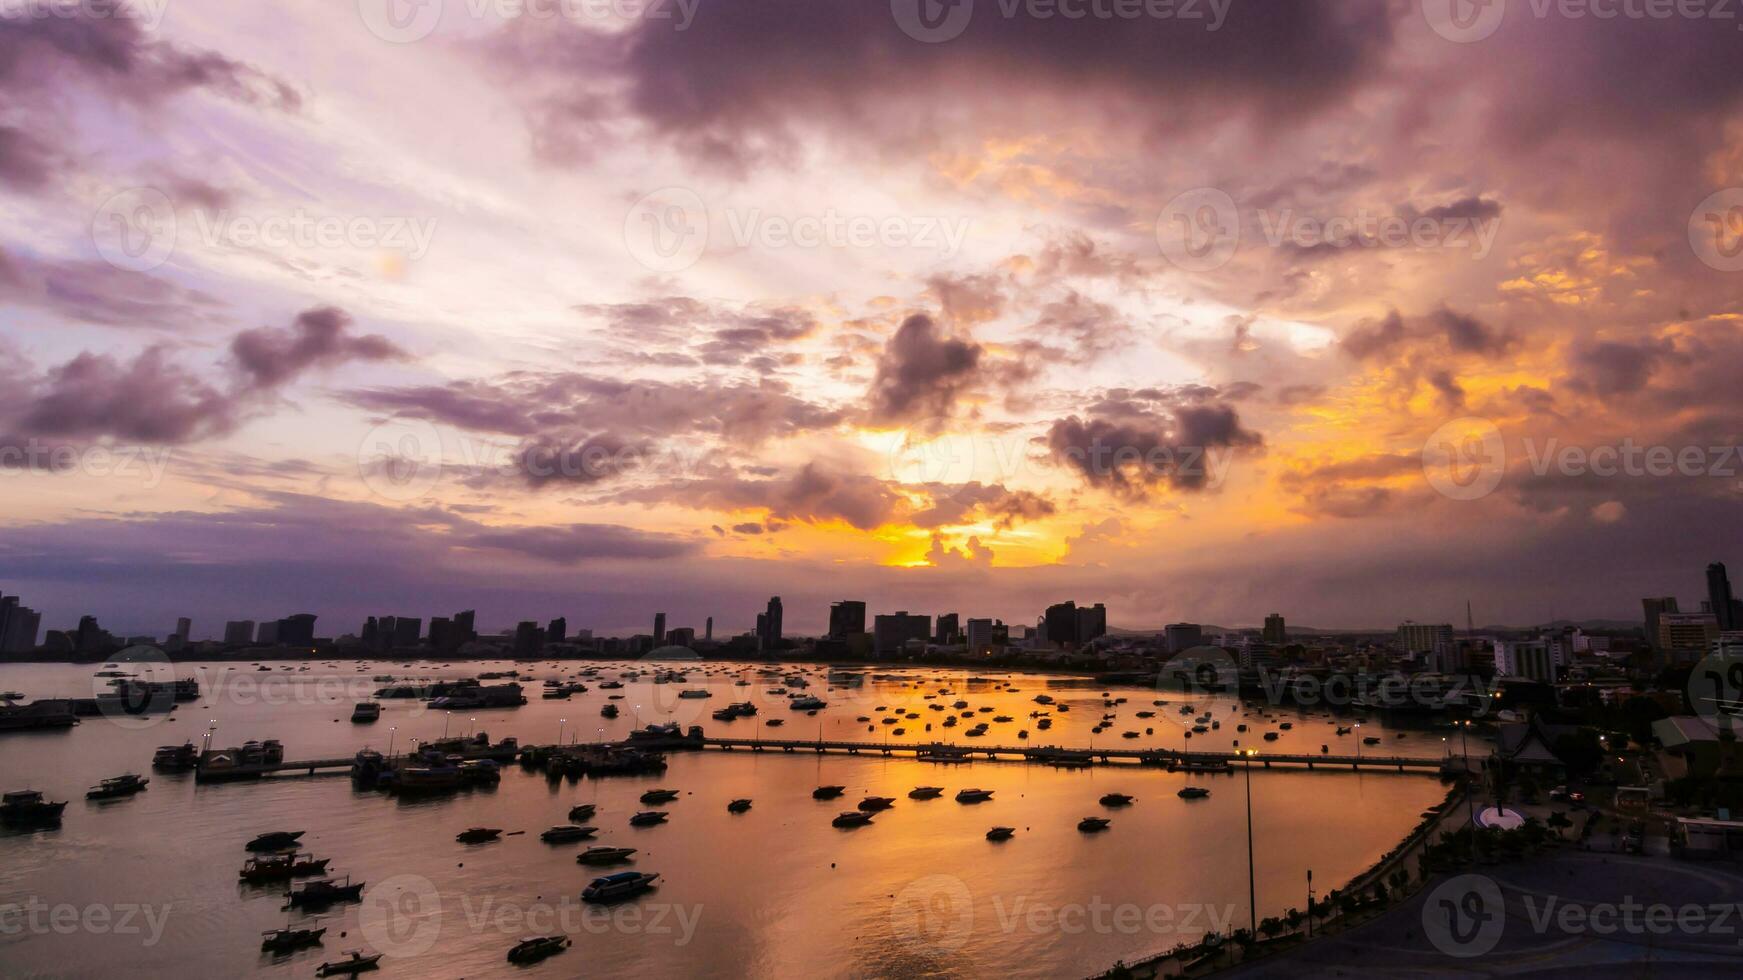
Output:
top-left (868, 314), bottom-right (983, 424)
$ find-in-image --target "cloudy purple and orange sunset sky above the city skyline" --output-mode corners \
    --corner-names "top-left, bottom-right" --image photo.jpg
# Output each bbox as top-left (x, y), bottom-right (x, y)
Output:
top-left (0, 0), bottom-right (1743, 636)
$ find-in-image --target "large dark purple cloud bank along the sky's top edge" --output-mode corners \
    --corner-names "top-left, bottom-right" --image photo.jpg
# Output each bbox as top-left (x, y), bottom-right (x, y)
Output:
top-left (490, 0), bottom-right (1393, 167)
